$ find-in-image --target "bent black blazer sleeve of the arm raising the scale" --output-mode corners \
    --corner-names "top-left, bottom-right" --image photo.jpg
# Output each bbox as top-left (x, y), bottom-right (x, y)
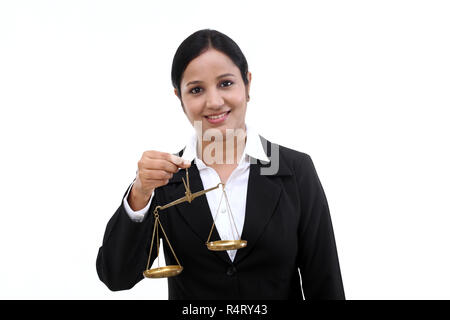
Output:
top-left (96, 184), bottom-right (158, 291)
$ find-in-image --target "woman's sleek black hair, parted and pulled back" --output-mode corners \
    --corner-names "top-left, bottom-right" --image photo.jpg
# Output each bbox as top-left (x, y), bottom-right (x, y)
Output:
top-left (172, 29), bottom-right (248, 100)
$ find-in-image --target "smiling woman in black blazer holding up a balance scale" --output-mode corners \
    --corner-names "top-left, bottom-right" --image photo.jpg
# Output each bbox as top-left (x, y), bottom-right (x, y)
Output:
top-left (97, 29), bottom-right (345, 300)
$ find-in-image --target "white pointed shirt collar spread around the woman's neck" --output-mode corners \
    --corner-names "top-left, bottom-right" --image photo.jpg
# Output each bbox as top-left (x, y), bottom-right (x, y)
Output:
top-left (181, 124), bottom-right (270, 170)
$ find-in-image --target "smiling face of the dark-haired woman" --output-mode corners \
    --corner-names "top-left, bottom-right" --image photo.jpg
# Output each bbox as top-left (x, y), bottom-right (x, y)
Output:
top-left (175, 49), bottom-right (251, 135)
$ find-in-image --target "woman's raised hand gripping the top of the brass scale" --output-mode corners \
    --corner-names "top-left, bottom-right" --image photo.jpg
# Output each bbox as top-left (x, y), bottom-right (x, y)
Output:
top-left (128, 150), bottom-right (191, 211)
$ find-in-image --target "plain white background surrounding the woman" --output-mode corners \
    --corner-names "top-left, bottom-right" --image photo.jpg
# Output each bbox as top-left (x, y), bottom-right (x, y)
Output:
top-left (0, 0), bottom-right (450, 299)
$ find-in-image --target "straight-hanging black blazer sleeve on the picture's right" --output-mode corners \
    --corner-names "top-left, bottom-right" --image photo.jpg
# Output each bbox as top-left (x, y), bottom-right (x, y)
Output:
top-left (296, 154), bottom-right (345, 300)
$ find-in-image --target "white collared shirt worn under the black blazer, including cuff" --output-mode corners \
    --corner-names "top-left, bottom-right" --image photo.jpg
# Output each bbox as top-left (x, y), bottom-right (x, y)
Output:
top-left (123, 124), bottom-right (269, 261)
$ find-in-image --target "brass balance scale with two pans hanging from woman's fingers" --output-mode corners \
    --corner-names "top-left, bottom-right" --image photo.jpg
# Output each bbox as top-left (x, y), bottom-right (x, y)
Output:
top-left (143, 168), bottom-right (247, 278)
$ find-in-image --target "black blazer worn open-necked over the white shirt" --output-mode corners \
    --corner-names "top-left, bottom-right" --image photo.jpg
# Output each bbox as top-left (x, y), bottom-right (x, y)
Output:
top-left (96, 137), bottom-right (345, 300)
